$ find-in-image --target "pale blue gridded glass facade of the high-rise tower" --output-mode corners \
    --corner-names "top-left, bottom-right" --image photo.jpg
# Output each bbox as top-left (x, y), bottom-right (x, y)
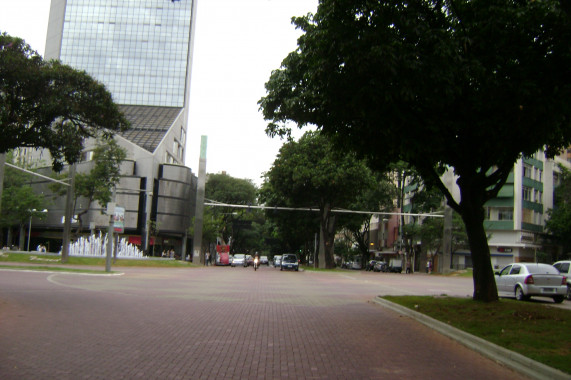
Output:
top-left (60, 0), bottom-right (192, 107)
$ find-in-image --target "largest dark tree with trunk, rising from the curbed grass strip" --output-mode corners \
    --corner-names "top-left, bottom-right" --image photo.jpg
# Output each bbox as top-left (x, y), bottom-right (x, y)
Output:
top-left (260, 0), bottom-right (571, 301)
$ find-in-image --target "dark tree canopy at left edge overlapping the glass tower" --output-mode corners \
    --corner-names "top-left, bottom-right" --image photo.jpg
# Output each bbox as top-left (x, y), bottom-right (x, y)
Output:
top-left (0, 33), bottom-right (129, 171)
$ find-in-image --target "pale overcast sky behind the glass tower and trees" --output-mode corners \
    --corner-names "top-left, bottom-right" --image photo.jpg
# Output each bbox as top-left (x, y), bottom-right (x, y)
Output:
top-left (0, 0), bottom-right (318, 185)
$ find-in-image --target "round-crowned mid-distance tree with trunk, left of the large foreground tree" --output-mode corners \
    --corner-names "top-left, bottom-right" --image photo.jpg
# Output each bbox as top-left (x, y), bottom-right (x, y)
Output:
top-left (261, 132), bottom-right (374, 268)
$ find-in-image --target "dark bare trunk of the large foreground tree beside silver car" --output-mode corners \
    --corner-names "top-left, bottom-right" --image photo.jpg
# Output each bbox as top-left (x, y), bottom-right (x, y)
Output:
top-left (462, 207), bottom-right (498, 302)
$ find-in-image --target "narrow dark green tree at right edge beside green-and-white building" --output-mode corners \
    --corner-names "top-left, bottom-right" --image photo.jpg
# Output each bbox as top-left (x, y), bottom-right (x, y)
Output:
top-left (545, 166), bottom-right (571, 257)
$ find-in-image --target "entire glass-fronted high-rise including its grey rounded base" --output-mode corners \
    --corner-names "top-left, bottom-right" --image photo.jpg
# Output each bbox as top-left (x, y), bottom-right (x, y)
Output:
top-left (26, 0), bottom-right (201, 257)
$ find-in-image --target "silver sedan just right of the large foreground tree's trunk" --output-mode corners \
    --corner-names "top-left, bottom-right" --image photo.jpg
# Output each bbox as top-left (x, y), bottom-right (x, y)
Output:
top-left (494, 263), bottom-right (567, 303)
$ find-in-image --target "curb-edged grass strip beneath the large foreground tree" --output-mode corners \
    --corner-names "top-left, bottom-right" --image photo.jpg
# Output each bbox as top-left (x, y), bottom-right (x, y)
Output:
top-left (382, 296), bottom-right (571, 374)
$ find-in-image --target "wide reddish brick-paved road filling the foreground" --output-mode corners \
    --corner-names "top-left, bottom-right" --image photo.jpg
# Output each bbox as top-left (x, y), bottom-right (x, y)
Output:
top-left (0, 267), bottom-right (532, 380)
